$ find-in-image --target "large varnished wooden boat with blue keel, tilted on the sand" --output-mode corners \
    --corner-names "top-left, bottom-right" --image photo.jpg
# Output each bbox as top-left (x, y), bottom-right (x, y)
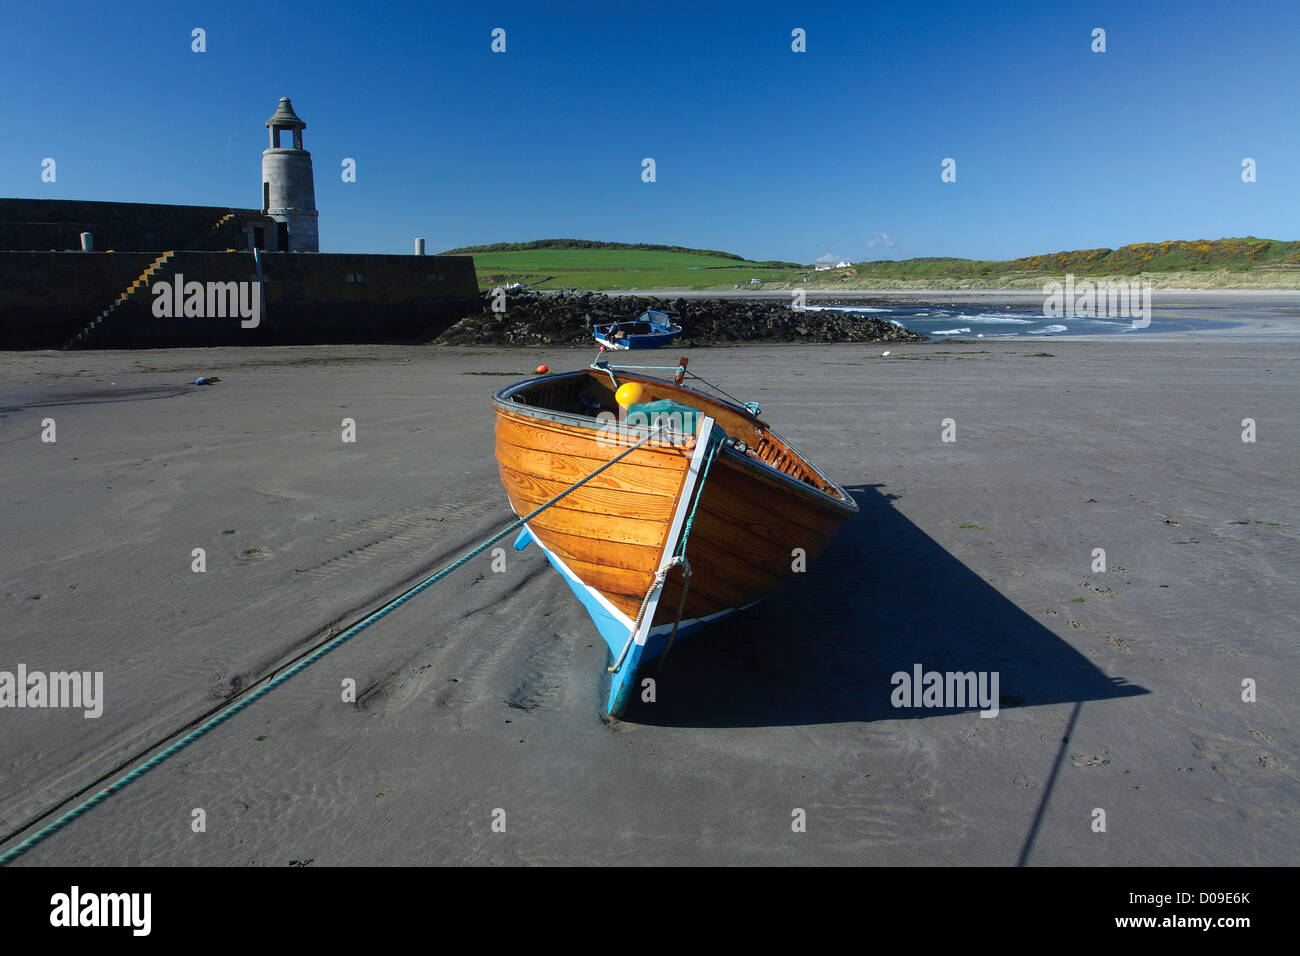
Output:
top-left (493, 360), bottom-right (858, 717)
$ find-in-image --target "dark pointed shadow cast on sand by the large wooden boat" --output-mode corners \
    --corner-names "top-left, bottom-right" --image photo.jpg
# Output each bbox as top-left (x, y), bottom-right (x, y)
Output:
top-left (624, 485), bottom-right (1149, 727)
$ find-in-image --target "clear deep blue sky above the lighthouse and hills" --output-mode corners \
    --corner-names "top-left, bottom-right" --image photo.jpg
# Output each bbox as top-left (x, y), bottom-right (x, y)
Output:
top-left (0, 0), bottom-right (1300, 263)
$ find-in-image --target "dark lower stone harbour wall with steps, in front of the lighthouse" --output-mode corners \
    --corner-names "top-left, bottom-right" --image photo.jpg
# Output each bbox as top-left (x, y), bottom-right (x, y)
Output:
top-left (0, 252), bottom-right (481, 349)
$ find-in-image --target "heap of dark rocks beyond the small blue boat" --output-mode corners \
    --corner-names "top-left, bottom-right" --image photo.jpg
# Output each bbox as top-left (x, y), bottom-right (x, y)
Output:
top-left (436, 293), bottom-right (926, 346)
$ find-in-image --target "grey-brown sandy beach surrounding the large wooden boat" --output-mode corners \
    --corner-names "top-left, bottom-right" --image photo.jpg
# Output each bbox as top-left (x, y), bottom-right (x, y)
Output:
top-left (0, 330), bottom-right (1300, 866)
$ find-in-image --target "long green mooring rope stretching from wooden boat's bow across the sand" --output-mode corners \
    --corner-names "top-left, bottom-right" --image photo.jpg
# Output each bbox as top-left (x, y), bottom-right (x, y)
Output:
top-left (0, 419), bottom-right (664, 866)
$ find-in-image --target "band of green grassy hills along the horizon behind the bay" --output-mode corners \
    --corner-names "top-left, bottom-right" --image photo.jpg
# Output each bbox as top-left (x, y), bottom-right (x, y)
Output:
top-left (449, 237), bottom-right (1300, 291)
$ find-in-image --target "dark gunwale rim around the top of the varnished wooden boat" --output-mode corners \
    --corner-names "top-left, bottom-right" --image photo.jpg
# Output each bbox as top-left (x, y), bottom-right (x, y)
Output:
top-left (491, 367), bottom-right (858, 518)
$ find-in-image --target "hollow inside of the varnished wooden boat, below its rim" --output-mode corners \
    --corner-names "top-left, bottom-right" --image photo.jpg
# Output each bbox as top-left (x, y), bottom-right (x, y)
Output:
top-left (496, 369), bottom-right (841, 498)
